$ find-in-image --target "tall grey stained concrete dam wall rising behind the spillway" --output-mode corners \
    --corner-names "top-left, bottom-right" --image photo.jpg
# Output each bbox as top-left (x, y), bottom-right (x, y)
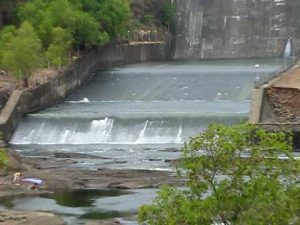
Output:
top-left (173, 0), bottom-right (300, 58)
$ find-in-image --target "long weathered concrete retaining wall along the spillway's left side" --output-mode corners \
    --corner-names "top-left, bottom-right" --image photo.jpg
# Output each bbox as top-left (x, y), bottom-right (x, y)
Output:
top-left (0, 43), bottom-right (169, 141)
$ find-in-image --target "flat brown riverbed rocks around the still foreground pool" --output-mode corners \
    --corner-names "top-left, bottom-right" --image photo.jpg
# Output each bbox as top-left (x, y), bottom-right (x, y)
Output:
top-left (0, 149), bottom-right (183, 225)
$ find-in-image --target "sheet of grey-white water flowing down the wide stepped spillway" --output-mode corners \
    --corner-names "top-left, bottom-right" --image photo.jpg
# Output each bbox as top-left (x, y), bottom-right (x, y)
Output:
top-left (10, 58), bottom-right (284, 169)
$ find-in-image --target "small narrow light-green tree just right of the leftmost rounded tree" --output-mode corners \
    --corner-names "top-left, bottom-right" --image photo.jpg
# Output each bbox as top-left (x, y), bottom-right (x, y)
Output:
top-left (46, 27), bottom-right (73, 67)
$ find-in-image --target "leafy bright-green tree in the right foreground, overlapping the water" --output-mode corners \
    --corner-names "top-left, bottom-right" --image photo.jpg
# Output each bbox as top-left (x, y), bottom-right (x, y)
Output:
top-left (139, 125), bottom-right (300, 225)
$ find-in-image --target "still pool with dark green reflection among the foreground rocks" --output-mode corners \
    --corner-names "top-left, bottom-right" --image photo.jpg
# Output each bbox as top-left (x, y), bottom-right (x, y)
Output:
top-left (0, 189), bottom-right (157, 225)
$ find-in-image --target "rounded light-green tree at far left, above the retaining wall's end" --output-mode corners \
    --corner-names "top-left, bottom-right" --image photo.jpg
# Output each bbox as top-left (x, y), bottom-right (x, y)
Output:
top-left (1, 21), bottom-right (42, 86)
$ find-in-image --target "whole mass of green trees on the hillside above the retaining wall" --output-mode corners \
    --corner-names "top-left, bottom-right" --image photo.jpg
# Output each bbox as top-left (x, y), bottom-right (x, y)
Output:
top-left (0, 0), bottom-right (130, 85)
